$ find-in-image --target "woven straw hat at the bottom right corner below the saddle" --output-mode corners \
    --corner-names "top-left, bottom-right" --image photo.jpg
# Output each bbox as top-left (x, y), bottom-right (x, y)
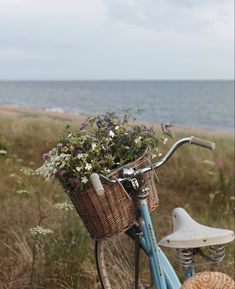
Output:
top-left (181, 272), bottom-right (235, 289)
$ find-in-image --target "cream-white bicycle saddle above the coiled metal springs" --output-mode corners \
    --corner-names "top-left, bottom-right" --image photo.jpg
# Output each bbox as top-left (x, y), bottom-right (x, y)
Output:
top-left (159, 208), bottom-right (234, 248)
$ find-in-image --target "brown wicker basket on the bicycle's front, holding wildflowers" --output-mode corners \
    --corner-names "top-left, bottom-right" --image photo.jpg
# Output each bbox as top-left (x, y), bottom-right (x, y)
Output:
top-left (69, 153), bottom-right (158, 239)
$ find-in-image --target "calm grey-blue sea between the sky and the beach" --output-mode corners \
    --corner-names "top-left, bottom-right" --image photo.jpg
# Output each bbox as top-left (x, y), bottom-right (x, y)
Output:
top-left (0, 80), bottom-right (234, 133)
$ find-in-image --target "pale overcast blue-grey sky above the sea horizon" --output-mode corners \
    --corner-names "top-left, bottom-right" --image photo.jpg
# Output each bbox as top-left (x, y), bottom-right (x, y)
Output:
top-left (0, 0), bottom-right (234, 80)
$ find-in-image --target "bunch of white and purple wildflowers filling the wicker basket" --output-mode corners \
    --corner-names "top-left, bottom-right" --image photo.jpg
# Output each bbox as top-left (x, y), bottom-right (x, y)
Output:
top-left (37, 113), bottom-right (169, 191)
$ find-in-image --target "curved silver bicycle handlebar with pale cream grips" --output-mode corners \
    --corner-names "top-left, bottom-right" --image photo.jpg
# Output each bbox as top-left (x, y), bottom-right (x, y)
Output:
top-left (90, 136), bottom-right (215, 191)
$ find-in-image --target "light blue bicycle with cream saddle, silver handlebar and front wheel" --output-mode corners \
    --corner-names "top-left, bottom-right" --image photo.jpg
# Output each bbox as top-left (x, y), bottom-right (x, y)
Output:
top-left (91, 137), bottom-right (234, 289)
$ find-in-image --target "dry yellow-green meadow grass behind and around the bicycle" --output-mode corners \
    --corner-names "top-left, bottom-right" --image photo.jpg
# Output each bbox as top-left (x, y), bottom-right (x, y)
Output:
top-left (0, 115), bottom-right (234, 289)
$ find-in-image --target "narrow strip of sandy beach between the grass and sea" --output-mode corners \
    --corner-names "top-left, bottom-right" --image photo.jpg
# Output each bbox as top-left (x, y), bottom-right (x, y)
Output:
top-left (0, 103), bottom-right (234, 138)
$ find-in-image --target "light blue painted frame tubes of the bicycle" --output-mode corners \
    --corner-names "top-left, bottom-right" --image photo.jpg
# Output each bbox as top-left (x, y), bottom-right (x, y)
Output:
top-left (136, 198), bottom-right (181, 289)
